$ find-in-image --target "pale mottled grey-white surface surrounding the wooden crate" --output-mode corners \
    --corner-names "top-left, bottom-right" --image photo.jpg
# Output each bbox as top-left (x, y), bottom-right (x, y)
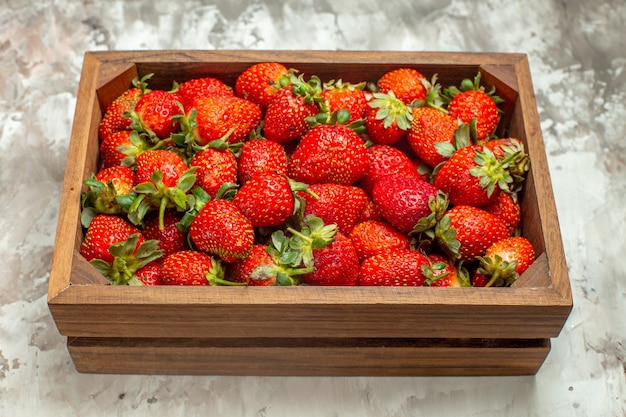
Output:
top-left (0, 0), bottom-right (626, 417)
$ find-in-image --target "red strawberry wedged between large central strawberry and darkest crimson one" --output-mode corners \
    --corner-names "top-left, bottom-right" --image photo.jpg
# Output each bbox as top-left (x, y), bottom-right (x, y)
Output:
top-left (359, 145), bottom-right (420, 194)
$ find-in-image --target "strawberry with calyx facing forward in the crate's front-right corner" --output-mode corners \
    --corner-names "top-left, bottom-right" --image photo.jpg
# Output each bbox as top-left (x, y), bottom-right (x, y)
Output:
top-left (474, 236), bottom-right (535, 287)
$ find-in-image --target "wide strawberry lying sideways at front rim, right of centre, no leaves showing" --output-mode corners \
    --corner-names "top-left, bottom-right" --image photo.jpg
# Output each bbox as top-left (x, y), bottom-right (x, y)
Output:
top-left (359, 249), bottom-right (429, 286)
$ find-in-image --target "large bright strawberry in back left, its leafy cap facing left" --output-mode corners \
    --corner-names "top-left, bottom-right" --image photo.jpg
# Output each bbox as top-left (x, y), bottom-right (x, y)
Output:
top-left (189, 95), bottom-right (261, 146)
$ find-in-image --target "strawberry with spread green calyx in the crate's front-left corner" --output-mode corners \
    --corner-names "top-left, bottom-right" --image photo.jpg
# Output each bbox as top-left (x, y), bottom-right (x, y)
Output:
top-left (80, 214), bottom-right (162, 285)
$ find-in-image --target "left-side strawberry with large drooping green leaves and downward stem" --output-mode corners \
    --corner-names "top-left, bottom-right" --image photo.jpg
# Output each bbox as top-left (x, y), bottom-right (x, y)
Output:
top-left (129, 150), bottom-right (196, 229)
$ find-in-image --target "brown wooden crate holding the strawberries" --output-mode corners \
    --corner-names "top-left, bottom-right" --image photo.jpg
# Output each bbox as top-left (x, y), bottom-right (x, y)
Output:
top-left (48, 51), bottom-right (572, 375)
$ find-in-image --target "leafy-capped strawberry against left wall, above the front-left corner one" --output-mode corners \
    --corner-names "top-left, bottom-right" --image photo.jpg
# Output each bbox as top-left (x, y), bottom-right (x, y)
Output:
top-left (81, 165), bottom-right (135, 225)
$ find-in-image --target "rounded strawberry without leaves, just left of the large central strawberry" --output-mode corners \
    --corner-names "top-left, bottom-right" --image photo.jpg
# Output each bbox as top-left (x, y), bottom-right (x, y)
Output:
top-left (237, 139), bottom-right (287, 185)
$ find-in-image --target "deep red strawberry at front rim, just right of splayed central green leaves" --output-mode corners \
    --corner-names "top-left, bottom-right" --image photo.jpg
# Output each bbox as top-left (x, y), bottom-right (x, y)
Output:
top-left (302, 233), bottom-right (360, 286)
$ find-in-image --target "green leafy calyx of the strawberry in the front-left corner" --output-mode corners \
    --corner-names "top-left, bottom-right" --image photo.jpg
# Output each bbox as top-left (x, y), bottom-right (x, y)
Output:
top-left (89, 233), bottom-right (163, 285)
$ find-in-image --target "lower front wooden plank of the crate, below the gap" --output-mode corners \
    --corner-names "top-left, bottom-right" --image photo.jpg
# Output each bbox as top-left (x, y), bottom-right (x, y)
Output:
top-left (68, 338), bottom-right (550, 376)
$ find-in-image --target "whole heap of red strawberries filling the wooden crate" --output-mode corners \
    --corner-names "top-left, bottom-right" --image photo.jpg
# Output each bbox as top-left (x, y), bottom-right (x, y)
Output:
top-left (81, 62), bottom-right (535, 286)
